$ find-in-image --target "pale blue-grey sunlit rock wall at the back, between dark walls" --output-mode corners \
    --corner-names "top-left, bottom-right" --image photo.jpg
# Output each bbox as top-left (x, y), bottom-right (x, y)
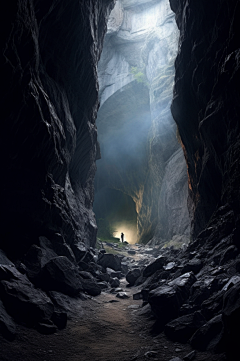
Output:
top-left (95, 0), bottom-right (189, 243)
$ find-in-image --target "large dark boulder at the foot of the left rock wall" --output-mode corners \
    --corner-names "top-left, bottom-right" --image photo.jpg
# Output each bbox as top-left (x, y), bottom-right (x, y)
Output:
top-left (40, 256), bottom-right (83, 296)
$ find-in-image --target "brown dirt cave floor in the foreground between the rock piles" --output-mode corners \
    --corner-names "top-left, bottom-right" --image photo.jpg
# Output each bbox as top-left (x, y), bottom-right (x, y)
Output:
top-left (0, 280), bottom-right (225, 361)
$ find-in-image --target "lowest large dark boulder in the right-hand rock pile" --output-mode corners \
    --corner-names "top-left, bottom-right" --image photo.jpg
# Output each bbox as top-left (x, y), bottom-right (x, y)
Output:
top-left (190, 315), bottom-right (224, 351)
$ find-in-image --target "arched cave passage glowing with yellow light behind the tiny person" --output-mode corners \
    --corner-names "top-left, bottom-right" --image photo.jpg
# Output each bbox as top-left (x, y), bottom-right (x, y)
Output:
top-left (94, 188), bottom-right (137, 244)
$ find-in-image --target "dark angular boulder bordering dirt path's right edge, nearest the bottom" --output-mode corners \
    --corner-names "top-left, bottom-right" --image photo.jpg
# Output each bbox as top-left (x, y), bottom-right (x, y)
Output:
top-left (164, 312), bottom-right (206, 343)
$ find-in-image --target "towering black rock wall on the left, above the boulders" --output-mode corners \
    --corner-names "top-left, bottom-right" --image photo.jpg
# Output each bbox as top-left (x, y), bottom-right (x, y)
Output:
top-left (0, 0), bottom-right (114, 253)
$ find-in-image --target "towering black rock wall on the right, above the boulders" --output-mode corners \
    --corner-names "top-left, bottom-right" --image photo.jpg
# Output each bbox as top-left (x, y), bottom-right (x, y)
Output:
top-left (171, 0), bottom-right (240, 237)
